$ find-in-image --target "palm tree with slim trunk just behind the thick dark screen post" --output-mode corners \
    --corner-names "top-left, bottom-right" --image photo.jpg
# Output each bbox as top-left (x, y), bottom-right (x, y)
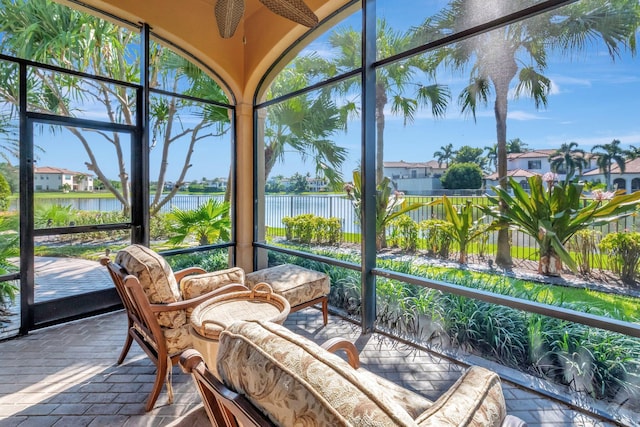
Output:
top-left (329, 20), bottom-right (450, 184)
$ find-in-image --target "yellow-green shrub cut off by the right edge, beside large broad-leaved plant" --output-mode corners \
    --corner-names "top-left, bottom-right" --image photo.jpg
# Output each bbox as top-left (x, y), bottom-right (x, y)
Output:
top-left (600, 231), bottom-right (640, 285)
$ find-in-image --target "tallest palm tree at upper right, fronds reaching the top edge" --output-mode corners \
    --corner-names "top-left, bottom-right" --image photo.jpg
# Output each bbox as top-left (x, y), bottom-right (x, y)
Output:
top-left (415, 0), bottom-right (640, 266)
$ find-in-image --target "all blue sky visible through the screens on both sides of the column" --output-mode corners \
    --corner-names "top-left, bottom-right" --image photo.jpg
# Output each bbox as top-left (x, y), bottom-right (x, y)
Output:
top-left (18, 0), bottom-right (640, 186)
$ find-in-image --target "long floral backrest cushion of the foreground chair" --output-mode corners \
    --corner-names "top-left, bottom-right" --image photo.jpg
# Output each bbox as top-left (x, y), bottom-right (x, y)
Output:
top-left (217, 321), bottom-right (417, 427)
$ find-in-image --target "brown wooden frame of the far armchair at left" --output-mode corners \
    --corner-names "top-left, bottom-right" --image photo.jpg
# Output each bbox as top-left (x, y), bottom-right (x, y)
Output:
top-left (100, 257), bottom-right (247, 411)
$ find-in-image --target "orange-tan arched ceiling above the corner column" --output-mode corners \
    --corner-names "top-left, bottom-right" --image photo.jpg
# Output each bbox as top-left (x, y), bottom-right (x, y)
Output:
top-left (61, 0), bottom-right (350, 103)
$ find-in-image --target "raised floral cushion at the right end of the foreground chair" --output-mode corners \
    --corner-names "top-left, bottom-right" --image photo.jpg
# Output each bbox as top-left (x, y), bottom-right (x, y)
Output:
top-left (416, 366), bottom-right (507, 427)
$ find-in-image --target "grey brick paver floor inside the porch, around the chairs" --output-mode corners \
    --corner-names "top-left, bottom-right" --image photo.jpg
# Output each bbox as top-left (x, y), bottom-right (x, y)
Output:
top-left (0, 309), bottom-right (624, 427)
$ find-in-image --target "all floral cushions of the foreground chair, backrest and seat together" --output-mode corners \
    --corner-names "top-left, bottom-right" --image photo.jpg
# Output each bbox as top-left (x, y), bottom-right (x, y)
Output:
top-left (217, 321), bottom-right (512, 427)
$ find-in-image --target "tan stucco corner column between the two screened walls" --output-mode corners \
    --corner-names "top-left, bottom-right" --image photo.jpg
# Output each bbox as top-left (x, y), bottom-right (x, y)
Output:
top-left (235, 103), bottom-right (253, 272)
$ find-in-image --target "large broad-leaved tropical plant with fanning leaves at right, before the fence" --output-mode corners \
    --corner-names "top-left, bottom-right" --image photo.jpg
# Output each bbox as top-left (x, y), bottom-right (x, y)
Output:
top-left (480, 174), bottom-right (640, 276)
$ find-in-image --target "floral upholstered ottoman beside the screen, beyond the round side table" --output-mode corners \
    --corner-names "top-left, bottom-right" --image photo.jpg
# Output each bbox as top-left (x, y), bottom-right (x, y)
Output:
top-left (245, 264), bottom-right (330, 325)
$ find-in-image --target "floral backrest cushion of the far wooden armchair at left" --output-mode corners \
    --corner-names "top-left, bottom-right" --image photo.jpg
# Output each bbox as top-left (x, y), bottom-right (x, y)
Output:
top-left (115, 245), bottom-right (187, 328)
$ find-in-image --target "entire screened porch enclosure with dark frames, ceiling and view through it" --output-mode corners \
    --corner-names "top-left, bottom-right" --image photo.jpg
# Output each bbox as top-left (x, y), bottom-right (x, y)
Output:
top-left (0, 0), bottom-right (640, 425)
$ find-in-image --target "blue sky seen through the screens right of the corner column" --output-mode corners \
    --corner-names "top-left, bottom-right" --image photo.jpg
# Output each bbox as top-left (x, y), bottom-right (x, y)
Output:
top-left (264, 4), bottom-right (640, 177)
